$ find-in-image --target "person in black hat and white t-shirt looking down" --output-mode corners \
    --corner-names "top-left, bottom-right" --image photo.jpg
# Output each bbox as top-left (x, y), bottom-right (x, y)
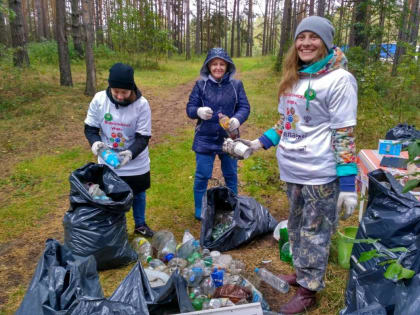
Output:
top-left (85, 63), bottom-right (153, 237)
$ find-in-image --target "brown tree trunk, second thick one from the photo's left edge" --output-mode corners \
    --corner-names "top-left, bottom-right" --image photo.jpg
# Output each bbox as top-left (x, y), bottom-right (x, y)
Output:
top-left (55, 0), bottom-right (73, 86)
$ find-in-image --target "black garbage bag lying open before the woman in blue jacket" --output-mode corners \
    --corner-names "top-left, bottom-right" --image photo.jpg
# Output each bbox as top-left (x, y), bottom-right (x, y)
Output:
top-left (200, 187), bottom-right (277, 251)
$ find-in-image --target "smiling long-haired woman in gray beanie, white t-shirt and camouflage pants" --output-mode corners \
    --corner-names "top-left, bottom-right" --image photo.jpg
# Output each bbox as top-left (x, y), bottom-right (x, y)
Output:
top-left (242, 16), bottom-right (357, 314)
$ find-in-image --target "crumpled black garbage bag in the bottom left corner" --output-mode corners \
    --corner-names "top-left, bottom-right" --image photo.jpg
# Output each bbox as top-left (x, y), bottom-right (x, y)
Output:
top-left (16, 239), bottom-right (103, 315)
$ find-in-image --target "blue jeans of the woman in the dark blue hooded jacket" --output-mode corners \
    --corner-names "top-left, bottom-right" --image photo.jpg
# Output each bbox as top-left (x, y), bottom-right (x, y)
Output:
top-left (194, 153), bottom-right (238, 218)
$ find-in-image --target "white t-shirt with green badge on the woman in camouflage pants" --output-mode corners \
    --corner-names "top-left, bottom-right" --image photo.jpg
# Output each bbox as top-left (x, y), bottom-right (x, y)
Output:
top-left (276, 69), bottom-right (357, 185)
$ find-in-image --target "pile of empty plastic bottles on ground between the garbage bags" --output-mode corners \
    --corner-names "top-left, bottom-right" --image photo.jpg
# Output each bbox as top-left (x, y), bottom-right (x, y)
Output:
top-left (132, 230), bottom-right (289, 310)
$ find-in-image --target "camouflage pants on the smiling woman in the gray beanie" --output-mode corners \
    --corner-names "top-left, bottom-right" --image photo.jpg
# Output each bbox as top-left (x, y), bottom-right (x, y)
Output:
top-left (287, 180), bottom-right (339, 291)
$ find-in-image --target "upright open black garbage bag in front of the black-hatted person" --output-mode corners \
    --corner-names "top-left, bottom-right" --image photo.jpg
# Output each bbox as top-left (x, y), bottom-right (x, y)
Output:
top-left (63, 163), bottom-right (137, 270)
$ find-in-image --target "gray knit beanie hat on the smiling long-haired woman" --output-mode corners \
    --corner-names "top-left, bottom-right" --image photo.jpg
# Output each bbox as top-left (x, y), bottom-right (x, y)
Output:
top-left (295, 15), bottom-right (335, 50)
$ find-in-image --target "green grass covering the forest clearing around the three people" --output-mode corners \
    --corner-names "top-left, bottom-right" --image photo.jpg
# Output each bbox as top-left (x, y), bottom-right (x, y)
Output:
top-left (0, 52), bottom-right (419, 314)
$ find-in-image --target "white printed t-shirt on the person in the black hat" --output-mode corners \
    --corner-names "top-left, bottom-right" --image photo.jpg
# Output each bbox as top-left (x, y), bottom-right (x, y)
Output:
top-left (85, 91), bottom-right (152, 176)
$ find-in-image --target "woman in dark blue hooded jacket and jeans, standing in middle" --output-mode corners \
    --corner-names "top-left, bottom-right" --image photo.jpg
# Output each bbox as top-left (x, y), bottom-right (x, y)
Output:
top-left (187, 48), bottom-right (250, 220)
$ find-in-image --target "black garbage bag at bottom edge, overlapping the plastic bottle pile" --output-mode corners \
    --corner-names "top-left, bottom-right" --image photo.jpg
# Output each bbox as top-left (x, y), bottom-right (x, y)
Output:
top-left (109, 262), bottom-right (194, 315)
